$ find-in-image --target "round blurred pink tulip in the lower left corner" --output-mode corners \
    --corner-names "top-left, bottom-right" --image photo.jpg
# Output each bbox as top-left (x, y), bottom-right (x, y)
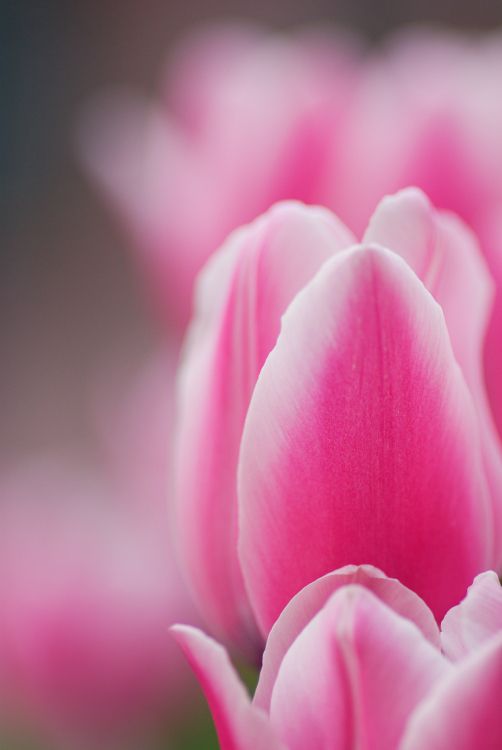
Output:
top-left (0, 461), bottom-right (195, 750)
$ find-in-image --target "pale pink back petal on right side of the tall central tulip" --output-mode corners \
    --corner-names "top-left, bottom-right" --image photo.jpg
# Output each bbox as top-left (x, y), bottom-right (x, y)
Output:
top-left (364, 188), bottom-right (502, 562)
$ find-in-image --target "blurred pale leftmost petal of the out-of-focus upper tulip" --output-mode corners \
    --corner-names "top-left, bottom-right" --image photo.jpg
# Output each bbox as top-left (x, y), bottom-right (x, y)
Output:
top-left (79, 92), bottom-right (219, 327)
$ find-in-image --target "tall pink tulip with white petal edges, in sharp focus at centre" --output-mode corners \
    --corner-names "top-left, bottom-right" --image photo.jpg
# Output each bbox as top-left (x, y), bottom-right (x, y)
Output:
top-left (175, 189), bottom-right (501, 648)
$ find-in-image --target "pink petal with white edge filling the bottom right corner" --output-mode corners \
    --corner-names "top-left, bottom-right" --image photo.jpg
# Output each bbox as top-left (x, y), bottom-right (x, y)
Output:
top-left (399, 633), bottom-right (502, 750)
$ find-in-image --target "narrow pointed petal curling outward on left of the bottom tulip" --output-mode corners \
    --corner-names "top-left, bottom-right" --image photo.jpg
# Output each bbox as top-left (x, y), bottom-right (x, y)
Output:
top-left (171, 625), bottom-right (281, 750)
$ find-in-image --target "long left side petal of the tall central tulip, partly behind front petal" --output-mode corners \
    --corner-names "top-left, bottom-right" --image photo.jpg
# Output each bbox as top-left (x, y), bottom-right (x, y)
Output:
top-left (175, 203), bottom-right (352, 649)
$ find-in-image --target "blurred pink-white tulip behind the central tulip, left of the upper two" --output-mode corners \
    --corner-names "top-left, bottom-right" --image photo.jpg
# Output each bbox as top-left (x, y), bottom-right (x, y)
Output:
top-left (82, 26), bottom-right (356, 322)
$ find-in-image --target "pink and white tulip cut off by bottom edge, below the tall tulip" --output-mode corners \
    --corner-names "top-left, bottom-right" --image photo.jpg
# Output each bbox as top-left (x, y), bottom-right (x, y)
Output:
top-left (174, 566), bottom-right (502, 750)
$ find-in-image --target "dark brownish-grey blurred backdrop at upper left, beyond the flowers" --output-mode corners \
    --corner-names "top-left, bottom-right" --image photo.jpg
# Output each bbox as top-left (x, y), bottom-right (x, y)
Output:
top-left (0, 0), bottom-right (502, 463)
